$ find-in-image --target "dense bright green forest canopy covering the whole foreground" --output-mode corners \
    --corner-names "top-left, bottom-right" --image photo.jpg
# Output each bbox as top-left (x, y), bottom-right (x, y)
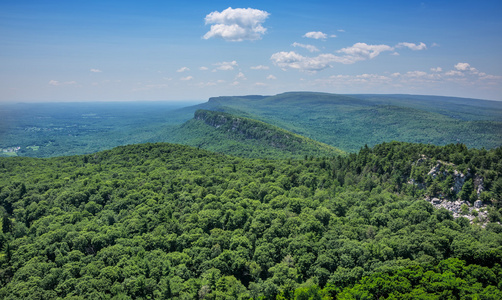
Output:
top-left (0, 142), bottom-right (502, 299)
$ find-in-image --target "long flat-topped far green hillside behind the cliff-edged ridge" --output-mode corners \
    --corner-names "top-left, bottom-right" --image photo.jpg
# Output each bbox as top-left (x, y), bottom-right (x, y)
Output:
top-left (173, 92), bottom-right (502, 152)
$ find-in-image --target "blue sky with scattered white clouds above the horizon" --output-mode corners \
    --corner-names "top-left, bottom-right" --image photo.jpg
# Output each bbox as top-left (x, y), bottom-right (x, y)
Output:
top-left (0, 0), bottom-right (502, 103)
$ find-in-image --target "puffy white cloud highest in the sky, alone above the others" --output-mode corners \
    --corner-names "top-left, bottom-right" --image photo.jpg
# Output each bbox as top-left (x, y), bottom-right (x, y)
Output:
top-left (203, 7), bottom-right (270, 42)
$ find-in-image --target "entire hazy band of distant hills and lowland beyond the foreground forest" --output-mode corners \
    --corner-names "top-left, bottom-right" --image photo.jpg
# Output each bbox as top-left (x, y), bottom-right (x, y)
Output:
top-left (0, 92), bottom-right (502, 158)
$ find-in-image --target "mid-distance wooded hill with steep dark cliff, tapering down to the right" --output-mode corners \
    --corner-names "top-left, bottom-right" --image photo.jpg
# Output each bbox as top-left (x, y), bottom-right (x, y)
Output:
top-left (159, 110), bottom-right (344, 158)
